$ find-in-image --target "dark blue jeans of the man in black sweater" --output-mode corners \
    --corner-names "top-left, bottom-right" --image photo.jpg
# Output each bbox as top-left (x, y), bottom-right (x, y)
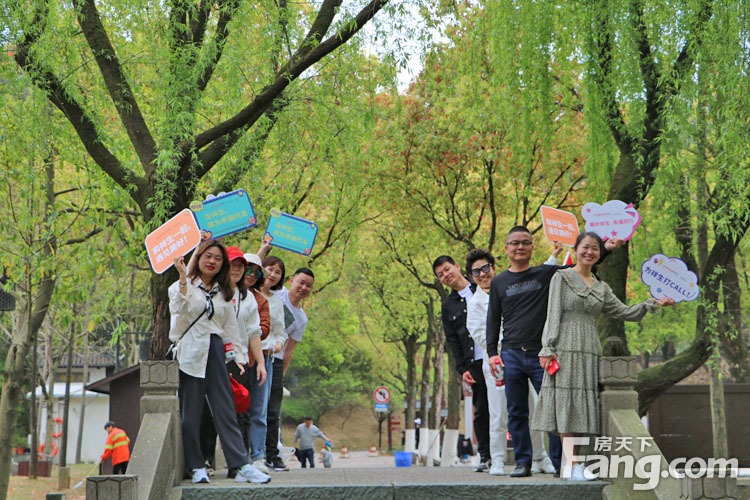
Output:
top-left (500, 349), bottom-right (562, 470)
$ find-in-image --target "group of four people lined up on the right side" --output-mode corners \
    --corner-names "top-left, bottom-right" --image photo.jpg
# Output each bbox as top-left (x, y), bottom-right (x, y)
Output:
top-left (433, 226), bottom-right (674, 481)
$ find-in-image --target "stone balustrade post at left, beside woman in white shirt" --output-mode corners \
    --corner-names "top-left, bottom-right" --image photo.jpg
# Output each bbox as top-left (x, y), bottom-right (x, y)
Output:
top-left (141, 360), bottom-right (185, 486)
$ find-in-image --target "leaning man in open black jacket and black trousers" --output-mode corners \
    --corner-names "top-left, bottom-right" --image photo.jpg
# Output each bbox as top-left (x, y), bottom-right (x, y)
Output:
top-left (432, 255), bottom-right (490, 472)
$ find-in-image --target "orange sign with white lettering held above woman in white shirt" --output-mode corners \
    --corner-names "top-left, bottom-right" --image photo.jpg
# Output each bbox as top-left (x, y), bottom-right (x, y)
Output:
top-left (145, 208), bottom-right (201, 274)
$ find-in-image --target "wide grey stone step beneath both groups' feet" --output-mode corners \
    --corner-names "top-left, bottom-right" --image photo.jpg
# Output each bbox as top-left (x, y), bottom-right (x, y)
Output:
top-left (178, 467), bottom-right (608, 500)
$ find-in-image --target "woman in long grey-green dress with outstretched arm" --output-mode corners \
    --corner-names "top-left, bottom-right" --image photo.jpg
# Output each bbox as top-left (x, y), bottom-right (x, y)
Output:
top-left (531, 232), bottom-right (674, 481)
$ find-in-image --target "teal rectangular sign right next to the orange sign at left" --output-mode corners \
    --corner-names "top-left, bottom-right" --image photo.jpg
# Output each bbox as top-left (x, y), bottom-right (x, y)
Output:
top-left (190, 189), bottom-right (258, 238)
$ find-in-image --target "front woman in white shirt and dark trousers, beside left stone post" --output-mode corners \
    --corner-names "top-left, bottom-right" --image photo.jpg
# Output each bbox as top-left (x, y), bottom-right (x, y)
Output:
top-left (169, 239), bottom-right (271, 483)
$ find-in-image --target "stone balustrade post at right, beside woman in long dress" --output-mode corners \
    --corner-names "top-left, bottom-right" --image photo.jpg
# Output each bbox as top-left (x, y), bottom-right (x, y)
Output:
top-left (599, 356), bottom-right (638, 436)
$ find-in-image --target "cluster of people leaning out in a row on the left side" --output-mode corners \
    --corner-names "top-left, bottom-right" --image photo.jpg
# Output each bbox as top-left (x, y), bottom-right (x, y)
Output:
top-left (169, 239), bottom-right (315, 484)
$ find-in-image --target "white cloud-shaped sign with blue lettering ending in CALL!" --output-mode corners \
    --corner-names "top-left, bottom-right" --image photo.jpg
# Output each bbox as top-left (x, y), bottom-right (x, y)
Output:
top-left (641, 253), bottom-right (700, 302)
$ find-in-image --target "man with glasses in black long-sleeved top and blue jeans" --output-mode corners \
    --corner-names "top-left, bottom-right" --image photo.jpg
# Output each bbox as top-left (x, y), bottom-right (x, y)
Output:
top-left (487, 226), bottom-right (622, 477)
